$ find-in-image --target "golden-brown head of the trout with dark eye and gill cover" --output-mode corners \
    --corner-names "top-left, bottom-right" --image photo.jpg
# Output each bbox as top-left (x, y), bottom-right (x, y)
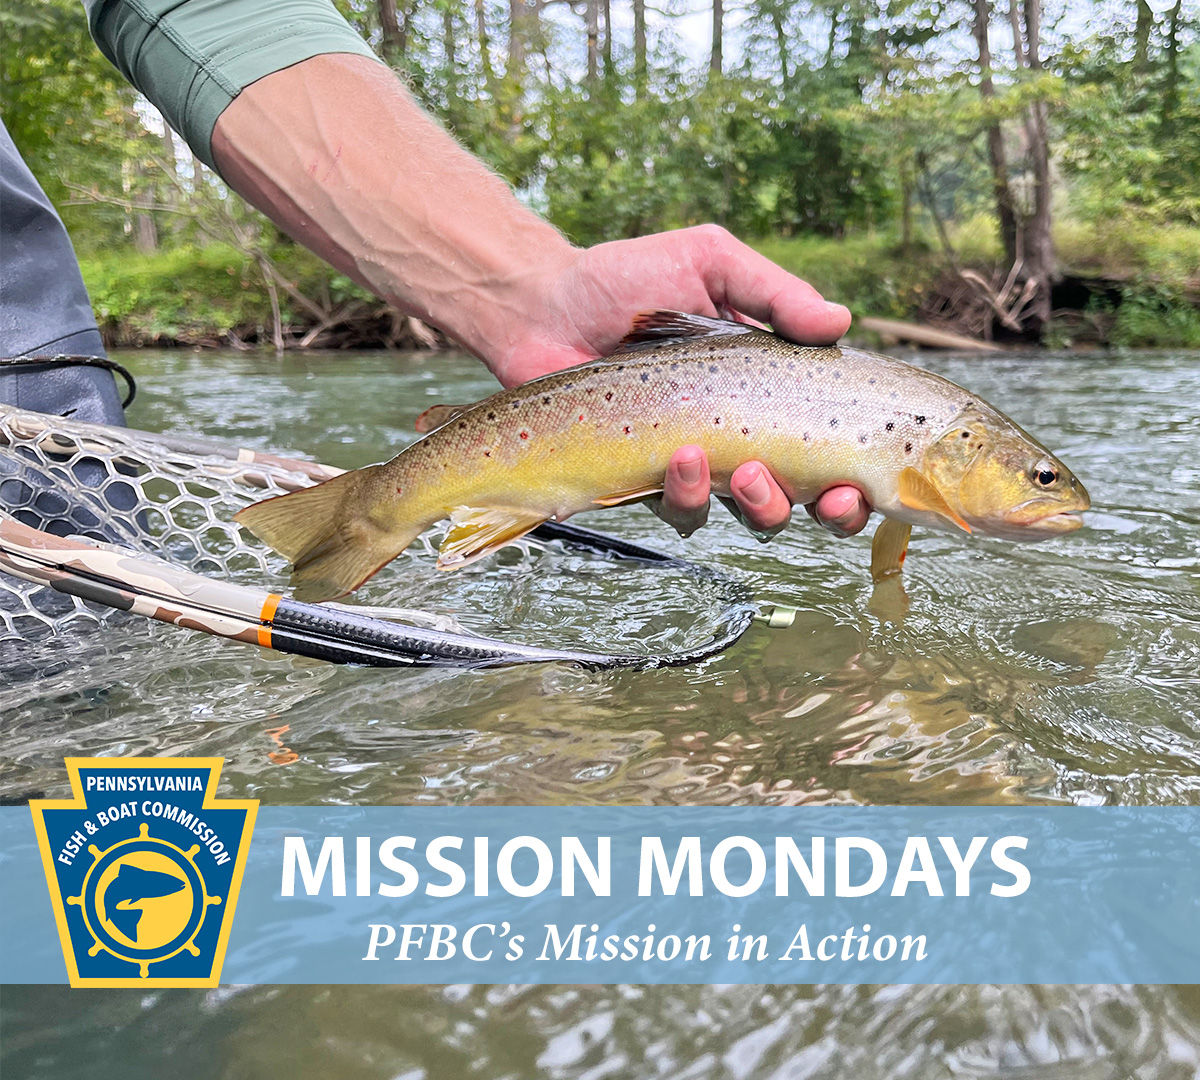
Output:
top-left (924, 406), bottom-right (1092, 540)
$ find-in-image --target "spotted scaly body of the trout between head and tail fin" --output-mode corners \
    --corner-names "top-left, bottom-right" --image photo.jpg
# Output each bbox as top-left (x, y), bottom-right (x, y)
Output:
top-left (384, 338), bottom-right (971, 517)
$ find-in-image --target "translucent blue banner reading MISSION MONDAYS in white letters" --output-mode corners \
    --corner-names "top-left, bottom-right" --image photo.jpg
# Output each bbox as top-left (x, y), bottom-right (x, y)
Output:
top-left (0, 804), bottom-right (1200, 985)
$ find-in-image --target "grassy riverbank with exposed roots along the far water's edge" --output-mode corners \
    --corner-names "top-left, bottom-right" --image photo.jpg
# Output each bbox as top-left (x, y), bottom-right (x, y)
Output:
top-left (80, 220), bottom-right (1200, 348)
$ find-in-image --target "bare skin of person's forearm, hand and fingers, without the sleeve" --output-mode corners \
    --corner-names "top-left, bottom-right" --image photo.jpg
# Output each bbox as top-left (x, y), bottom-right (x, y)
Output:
top-left (212, 56), bottom-right (869, 535)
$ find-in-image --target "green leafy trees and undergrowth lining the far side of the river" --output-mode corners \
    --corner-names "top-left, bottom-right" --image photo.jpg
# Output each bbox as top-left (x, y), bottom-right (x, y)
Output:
top-left (0, 0), bottom-right (1200, 342)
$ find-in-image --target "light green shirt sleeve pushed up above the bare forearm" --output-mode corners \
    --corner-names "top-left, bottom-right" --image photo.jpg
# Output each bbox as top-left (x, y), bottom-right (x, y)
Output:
top-left (84, 0), bottom-right (374, 168)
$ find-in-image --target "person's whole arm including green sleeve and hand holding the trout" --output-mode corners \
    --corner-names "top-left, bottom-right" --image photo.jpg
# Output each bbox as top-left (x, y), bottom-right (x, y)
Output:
top-left (91, 0), bottom-right (865, 532)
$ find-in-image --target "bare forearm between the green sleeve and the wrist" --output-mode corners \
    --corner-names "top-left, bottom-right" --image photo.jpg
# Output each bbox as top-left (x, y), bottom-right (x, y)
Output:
top-left (212, 55), bottom-right (575, 359)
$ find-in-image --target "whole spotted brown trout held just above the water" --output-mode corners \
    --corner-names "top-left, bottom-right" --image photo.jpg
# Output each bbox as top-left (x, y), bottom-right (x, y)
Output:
top-left (236, 312), bottom-right (1090, 600)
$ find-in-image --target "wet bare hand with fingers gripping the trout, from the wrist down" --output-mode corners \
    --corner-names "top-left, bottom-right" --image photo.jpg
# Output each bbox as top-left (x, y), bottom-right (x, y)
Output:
top-left (487, 226), bottom-right (870, 539)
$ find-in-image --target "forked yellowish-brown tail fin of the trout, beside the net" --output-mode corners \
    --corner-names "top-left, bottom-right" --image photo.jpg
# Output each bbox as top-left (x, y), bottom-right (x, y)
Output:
top-left (234, 466), bottom-right (424, 600)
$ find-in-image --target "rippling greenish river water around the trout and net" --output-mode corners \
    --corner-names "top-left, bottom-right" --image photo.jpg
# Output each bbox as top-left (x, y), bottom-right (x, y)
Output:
top-left (0, 352), bottom-right (1200, 1080)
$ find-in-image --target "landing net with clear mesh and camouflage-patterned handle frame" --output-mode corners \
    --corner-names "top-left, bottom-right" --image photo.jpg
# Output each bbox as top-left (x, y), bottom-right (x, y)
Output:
top-left (0, 404), bottom-right (754, 666)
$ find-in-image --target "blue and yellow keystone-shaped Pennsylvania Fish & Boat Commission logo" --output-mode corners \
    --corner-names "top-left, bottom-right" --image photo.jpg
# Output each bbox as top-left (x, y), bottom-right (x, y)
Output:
top-left (30, 757), bottom-right (258, 986)
